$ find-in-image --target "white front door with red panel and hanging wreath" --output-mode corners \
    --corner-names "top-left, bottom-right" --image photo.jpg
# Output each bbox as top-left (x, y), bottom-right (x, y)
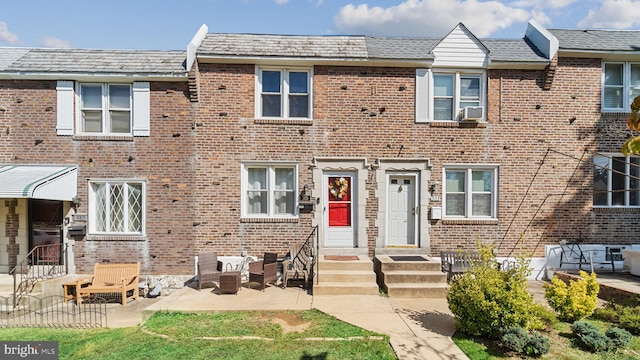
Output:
top-left (324, 173), bottom-right (357, 248)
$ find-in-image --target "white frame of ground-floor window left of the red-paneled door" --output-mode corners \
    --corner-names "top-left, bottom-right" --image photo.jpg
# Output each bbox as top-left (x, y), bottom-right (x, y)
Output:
top-left (240, 162), bottom-right (300, 219)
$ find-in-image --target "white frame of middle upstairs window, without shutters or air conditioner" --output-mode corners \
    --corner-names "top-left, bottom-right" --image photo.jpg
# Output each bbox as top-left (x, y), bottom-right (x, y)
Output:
top-left (255, 65), bottom-right (313, 120)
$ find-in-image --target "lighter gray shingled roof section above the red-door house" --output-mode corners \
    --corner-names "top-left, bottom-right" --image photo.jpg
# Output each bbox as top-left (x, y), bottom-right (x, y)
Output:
top-left (198, 34), bottom-right (367, 58)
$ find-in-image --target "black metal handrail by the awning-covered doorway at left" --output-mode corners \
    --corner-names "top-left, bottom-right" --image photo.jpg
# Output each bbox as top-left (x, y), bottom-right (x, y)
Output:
top-left (9, 243), bottom-right (69, 307)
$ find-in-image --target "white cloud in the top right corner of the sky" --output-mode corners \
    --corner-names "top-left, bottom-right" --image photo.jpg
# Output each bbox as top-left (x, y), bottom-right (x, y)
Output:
top-left (578, 0), bottom-right (640, 29)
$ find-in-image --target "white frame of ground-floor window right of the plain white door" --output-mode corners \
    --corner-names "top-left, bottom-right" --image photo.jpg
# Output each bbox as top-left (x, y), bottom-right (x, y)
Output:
top-left (442, 164), bottom-right (499, 220)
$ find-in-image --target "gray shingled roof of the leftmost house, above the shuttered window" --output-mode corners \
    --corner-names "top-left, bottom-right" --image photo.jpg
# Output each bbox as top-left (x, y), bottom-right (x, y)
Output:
top-left (0, 48), bottom-right (186, 76)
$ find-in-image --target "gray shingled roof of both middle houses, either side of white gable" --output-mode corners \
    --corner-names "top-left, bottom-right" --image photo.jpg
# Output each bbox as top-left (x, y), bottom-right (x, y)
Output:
top-left (198, 34), bottom-right (548, 62)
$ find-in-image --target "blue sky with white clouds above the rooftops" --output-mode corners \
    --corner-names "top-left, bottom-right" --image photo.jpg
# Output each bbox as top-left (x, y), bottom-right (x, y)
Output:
top-left (0, 0), bottom-right (640, 50)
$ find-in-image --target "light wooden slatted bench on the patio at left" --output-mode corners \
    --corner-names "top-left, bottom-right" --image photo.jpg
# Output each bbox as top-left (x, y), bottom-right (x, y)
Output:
top-left (76, 262), bottom-right (140, 305)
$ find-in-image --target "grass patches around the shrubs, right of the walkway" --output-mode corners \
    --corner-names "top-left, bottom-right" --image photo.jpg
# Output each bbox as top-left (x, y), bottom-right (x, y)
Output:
top-left (453, 320), bottom-right (640, 360)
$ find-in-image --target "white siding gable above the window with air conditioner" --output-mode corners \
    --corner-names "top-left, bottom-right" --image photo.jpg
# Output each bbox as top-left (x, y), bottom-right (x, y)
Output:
top-left (433, 26), bottom-right (488, 68)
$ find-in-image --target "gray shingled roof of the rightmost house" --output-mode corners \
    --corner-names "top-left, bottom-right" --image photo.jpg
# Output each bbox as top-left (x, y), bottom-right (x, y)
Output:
top-left (548, 29), bottom-right (640, 52)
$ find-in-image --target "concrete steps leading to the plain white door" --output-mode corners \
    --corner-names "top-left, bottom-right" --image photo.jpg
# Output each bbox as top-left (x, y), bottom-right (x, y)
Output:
top-left (374, 255), bottom-right (448, 299)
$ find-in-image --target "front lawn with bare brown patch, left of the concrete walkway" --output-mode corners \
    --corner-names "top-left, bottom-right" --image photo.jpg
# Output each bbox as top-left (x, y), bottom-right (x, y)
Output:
top-left (0, 310), bottom-right (397, 360)
